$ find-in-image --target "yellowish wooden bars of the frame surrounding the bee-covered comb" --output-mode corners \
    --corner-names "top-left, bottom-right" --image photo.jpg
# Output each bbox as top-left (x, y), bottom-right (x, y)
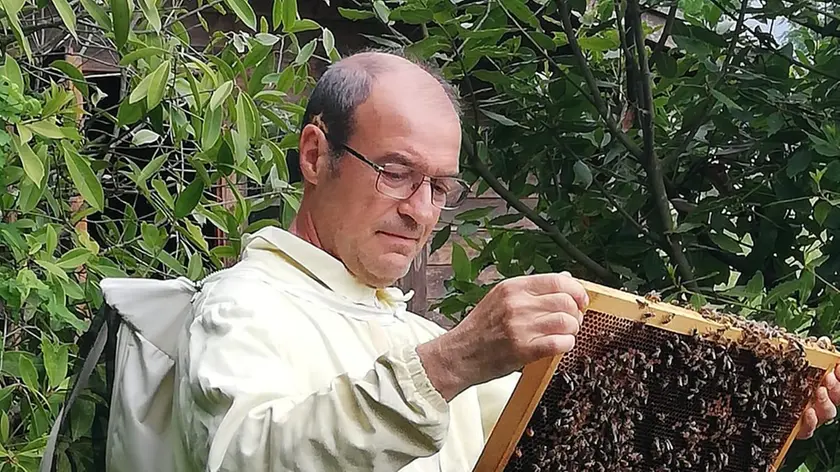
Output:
top-left (474, 281), bottom-right (840, 472)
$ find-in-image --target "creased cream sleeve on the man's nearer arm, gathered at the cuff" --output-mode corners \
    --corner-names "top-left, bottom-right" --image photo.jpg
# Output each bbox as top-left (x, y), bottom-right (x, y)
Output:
top-left (183, 284), bottom-right (449, 472)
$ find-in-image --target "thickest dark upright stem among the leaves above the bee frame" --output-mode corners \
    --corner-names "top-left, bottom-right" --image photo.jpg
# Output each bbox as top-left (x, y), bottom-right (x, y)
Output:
top-left (628, 0), bottom-right (697, 288)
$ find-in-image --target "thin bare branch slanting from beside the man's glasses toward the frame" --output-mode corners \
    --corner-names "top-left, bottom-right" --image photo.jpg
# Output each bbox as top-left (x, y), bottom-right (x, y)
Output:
top-left (464, 136), bottom-right (618, 283)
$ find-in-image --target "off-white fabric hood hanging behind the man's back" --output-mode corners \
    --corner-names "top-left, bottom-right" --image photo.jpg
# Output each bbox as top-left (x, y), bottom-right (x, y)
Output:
top-left (100, 278), bottom-right (196, 472)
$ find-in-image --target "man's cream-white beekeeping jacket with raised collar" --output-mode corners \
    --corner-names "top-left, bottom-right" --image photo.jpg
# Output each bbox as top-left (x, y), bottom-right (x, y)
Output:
top-left (103, 227), bottom-right (518, 472)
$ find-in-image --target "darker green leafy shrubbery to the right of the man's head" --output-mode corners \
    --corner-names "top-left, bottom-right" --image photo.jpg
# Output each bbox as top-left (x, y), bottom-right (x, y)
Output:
top-left (342, 0), bottom-right (840, 471)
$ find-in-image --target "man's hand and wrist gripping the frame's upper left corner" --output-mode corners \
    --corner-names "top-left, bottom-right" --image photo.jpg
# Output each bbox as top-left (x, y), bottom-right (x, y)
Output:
top-left (417, 272), bottom-right (589, 401)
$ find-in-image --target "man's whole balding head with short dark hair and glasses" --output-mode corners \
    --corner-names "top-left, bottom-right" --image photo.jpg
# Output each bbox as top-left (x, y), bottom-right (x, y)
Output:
top-left (295, 48), bottom-right (461, 286)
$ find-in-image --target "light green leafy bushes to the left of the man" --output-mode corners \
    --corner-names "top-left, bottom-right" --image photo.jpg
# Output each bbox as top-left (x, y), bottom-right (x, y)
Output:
top-left (0, 0), bottom-right (340, 471)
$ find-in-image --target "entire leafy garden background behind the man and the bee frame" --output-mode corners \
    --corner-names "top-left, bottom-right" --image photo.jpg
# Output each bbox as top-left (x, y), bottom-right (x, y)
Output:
top-left (0, 0), bottom-right (840, 472)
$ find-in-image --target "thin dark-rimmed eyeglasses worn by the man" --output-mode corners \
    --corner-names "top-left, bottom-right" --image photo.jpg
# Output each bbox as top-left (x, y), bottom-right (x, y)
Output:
top-left (332, 139), bottom-right (470, 210)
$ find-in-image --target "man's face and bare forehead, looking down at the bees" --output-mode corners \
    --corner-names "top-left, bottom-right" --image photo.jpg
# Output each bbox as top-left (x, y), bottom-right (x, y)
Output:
top-left (315, 71), bottom-right (461, 286)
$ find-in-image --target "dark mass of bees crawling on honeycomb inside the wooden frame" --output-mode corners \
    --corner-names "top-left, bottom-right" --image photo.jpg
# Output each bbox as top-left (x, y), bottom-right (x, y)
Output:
top-left (505, 304), bottom-right (830, 472)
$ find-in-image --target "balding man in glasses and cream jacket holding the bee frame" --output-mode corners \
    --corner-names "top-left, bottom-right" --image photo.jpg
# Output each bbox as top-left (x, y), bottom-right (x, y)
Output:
top-left (173, 49), bottom-right (840, 472)
